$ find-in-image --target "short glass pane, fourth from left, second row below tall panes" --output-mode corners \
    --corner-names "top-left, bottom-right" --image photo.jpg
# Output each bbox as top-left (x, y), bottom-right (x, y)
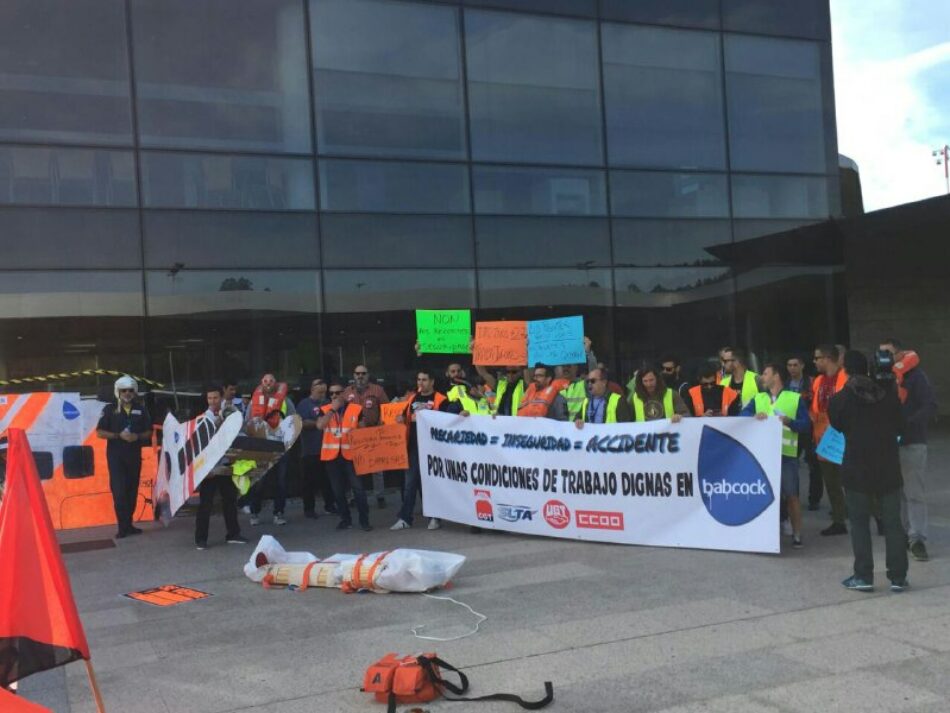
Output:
top-left (475, 216), bottom-right (610, 267)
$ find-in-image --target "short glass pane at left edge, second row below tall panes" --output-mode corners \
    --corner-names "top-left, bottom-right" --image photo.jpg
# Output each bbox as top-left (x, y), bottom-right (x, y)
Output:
top-left (0, 208), bottom-right (142, 269)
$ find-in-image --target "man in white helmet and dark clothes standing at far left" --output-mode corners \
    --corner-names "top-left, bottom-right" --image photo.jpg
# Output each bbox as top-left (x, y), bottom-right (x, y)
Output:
top-left (96, 376), bottom-right (152, 538)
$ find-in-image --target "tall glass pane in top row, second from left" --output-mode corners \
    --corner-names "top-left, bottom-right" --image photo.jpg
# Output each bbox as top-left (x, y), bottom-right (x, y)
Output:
top-left (132, 0), bottom-right (310, 153)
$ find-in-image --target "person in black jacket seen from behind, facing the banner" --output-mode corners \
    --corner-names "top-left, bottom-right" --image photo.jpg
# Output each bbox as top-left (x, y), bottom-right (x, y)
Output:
top-left (828, 351), bottom-right (907, 592)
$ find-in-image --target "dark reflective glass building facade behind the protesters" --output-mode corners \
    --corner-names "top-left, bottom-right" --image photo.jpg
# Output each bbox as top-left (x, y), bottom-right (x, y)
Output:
top-left (0, 0), bottom-right (846, 388)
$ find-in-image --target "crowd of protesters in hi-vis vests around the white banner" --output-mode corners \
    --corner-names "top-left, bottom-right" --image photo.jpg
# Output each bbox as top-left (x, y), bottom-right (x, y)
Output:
top-left (99, 338), bottom-right (937, 591)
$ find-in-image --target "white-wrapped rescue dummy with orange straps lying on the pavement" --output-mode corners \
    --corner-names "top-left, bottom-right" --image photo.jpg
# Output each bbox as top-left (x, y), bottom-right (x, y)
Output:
top-left (244, 535), bottom-right (465, 594)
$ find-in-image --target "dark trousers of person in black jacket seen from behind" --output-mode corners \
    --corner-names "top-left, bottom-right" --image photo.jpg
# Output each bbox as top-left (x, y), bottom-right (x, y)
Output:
top-left (847, 490), bottom-right (907, 582)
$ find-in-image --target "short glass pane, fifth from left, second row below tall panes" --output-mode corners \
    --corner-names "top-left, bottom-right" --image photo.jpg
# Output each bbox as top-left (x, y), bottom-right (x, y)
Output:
top-left (612, 218), bottom-right (732, 265)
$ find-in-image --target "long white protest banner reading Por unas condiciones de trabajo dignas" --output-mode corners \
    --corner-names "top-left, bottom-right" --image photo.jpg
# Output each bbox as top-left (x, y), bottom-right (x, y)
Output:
top-left (416, 411), bottom-right (782, 553)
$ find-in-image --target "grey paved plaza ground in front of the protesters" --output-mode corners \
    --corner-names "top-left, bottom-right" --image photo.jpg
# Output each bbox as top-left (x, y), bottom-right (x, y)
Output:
top-left (22, 435), bottom-right (950, 713)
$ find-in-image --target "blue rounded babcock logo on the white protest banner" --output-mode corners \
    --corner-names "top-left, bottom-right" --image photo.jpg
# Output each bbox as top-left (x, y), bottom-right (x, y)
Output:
top-left (697, 426), bottom-right (775, 526)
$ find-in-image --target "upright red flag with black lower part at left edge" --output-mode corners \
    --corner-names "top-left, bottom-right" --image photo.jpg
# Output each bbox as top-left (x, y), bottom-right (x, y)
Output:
top-left (0, 428), bottom-right (89, 686)
